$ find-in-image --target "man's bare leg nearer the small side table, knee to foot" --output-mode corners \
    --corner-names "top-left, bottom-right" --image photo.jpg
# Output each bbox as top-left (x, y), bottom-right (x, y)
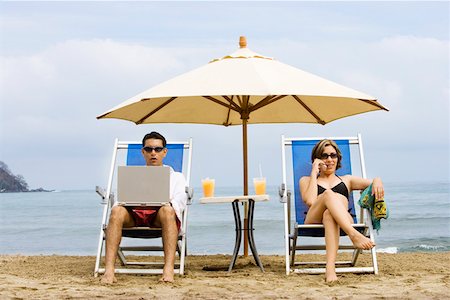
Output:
top-left (155, 205), bottom-right (178, 282)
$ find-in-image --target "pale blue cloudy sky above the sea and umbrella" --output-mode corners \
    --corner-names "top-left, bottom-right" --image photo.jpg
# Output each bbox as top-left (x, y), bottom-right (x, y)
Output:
top-left (0, 1), bottom-right (450, 189)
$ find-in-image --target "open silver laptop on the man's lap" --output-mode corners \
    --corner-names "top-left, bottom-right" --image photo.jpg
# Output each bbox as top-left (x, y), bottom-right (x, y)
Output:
top-left (117, 166), bottom-right (170, 206)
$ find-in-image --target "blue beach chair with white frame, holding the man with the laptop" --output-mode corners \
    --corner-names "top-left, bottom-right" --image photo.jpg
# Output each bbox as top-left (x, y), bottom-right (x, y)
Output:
top-left (94, 139), bottom-right (193, 276)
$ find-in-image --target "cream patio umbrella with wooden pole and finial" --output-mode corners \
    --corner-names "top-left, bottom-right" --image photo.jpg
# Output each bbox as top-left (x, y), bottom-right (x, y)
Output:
top-left (97, 37), bottom-right (387, 253)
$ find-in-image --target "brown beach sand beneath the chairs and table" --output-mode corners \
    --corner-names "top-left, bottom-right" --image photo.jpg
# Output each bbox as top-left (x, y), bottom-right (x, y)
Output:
top-left (0, 252), bottom-right (450, 299)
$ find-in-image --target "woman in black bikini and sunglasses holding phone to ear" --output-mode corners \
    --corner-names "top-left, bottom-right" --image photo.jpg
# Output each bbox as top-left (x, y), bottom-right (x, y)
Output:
top-left (299, 140), bottom-right (384, 282)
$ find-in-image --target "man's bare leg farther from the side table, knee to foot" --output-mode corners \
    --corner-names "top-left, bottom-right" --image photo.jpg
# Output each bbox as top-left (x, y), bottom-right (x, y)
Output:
top-left (101, 206), bottom-right (134, 284)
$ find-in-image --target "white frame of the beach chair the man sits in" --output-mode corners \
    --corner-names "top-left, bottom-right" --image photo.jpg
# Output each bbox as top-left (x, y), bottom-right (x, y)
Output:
top-left (94, 138), bottom-right (193, 277)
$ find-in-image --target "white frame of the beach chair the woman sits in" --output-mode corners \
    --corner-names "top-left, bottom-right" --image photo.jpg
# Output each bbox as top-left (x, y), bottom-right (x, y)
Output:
top-left (279, 134), bottom-right (378, 275)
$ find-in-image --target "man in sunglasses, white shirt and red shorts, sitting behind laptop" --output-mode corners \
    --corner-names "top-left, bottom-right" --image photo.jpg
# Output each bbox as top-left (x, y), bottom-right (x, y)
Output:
top-left (102, 132), bottom-right (187, 283)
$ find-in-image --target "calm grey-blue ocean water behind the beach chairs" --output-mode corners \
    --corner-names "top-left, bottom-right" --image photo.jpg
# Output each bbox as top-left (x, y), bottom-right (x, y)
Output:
top-left (0, 182), bottom-right (450, 255)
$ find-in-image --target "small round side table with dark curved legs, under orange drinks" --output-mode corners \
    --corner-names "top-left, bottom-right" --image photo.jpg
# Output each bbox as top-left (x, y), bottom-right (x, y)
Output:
top-left (200, 195), bottom-right (270, 272)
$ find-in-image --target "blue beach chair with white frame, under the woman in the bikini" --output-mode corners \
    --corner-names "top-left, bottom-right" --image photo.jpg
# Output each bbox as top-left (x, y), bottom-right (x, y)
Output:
top-left (280, 134), bottom-right (378, 275)
